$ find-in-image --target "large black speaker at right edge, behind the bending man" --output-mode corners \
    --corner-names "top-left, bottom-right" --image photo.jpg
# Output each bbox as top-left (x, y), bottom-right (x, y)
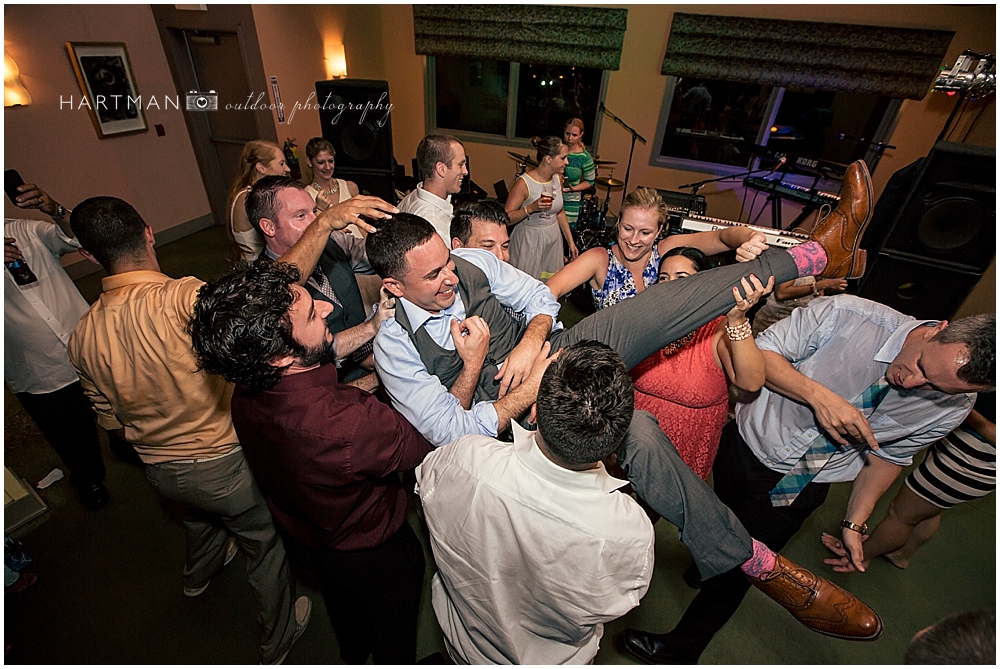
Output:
top-left (858, 142), bottom-right (996, 320)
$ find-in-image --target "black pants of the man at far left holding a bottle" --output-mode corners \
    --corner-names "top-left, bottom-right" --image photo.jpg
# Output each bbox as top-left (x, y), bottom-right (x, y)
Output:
top-left (17, 381), bottom-right (105, 488)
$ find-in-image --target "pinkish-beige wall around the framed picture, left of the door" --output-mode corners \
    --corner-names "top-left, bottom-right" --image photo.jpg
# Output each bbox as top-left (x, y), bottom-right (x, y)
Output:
top-left (4, 5), bottom-right (210, 248)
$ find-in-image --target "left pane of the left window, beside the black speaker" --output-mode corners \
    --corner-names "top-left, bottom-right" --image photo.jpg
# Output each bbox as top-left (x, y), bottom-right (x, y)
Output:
top-left (436, 56), bottom-right (510, 136)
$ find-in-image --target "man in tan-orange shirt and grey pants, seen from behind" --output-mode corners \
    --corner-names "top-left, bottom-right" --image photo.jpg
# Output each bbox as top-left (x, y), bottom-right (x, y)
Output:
top-left (69, 197), bottom-right (394, 664)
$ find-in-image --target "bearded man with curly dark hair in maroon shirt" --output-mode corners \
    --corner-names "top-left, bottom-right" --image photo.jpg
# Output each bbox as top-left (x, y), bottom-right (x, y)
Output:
top-left (190, 261), bottom-right (431, 664)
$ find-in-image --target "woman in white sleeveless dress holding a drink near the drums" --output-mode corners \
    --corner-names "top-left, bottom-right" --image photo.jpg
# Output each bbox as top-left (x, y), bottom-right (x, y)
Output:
top-left (505, 136), bottom-right (580, 281)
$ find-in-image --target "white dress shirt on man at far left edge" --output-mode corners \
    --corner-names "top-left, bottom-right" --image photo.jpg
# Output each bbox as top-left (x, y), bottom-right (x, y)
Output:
top-left (3, 218), bottom-right (89, 394)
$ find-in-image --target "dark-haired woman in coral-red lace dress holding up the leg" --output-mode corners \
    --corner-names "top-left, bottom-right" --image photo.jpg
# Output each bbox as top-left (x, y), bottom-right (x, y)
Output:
top-left (632, 246), bottom-right (774, 479)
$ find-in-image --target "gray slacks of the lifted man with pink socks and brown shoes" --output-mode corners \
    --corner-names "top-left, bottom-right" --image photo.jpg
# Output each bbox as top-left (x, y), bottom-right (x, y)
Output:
top-left (550, 249), bottom-right (798, 578)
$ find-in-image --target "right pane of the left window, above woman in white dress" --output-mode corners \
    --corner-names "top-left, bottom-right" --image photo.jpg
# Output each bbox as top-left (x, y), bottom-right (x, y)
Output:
top-left (514, 63), bottom-right (604, 143)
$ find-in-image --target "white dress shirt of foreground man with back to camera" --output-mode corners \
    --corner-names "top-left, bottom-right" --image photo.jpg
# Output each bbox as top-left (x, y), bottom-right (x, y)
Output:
top-left (416, 424), bottom-right (653, 664)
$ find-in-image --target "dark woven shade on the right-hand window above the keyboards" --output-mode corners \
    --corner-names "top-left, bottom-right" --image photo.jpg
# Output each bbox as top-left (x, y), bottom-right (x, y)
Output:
top-left (661, 12), bottom-right (955, 99)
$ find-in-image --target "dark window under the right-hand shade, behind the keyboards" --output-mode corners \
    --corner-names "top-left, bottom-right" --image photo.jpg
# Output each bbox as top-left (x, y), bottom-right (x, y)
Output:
top-left (651, 77), bottom-right (901, 174)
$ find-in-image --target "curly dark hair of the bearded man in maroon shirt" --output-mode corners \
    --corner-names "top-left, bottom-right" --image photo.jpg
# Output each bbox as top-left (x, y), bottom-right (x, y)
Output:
top-left (188, 258), bottom-right (305, 391)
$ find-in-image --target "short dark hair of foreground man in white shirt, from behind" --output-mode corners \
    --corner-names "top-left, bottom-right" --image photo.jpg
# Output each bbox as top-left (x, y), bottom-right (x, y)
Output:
top-left (537, 341), bottom-right (635, 465)
